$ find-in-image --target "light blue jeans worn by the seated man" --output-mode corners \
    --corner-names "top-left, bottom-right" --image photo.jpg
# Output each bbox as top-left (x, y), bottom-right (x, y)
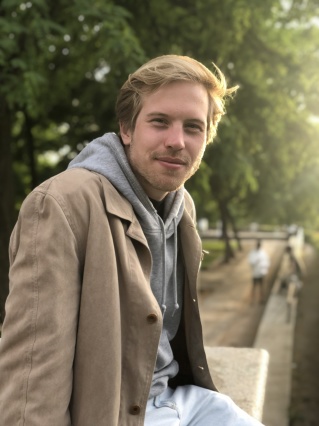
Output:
top-left (144, 385), bottom-right (261, 426)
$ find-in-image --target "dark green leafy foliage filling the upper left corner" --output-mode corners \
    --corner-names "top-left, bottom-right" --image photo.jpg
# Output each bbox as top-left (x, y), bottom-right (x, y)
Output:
top-left (0, 0), bottom-right (143, 115)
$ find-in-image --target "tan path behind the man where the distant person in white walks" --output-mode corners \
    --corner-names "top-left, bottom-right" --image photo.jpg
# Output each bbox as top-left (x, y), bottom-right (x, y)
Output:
top-left (199, 240), bottom-right (286, 347)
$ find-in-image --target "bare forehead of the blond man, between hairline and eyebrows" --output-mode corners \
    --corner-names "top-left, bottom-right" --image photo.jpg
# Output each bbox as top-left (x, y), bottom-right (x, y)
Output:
top-left (141, 81), bottom-right (209, 120)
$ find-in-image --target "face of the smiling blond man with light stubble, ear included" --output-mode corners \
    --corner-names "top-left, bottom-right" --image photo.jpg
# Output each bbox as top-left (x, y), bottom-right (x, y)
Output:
top-left (121, 81), bottom-right (208, 200)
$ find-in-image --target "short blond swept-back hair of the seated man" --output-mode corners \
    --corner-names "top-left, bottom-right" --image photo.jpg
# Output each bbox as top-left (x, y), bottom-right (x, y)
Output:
top-left (116, 55), bottom-right (238, 143)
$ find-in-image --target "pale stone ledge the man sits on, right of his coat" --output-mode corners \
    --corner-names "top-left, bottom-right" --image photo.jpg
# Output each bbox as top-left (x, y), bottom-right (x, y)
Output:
top-left (205, 346), bottom-right (269, 421)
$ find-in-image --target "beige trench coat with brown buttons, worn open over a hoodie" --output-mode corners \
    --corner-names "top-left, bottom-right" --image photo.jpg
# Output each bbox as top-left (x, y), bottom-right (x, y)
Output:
top-left (0, 169), bottom-right (215, 426)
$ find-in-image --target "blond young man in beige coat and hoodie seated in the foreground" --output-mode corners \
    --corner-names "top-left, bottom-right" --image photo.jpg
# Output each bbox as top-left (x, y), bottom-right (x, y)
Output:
top-left (0, 55), bottom-right (260, 426)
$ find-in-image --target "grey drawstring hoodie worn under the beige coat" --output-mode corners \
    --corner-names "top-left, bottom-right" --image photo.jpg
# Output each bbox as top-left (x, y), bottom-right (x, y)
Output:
top-left (69, 133), bottom-right (184, 397)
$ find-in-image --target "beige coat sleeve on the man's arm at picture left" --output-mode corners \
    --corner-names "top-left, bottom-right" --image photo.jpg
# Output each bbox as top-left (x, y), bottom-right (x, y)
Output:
top-left (0, 190), bottom-right (81, 426)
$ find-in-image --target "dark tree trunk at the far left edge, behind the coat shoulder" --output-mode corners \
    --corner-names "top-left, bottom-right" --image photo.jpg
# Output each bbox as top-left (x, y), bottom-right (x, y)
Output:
top-left (0, 95), bottom-right (14, 323)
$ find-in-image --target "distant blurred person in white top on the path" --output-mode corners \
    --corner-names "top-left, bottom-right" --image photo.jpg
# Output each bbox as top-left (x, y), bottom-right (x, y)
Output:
top-left (248, 240), bottom-right (270, 303)
